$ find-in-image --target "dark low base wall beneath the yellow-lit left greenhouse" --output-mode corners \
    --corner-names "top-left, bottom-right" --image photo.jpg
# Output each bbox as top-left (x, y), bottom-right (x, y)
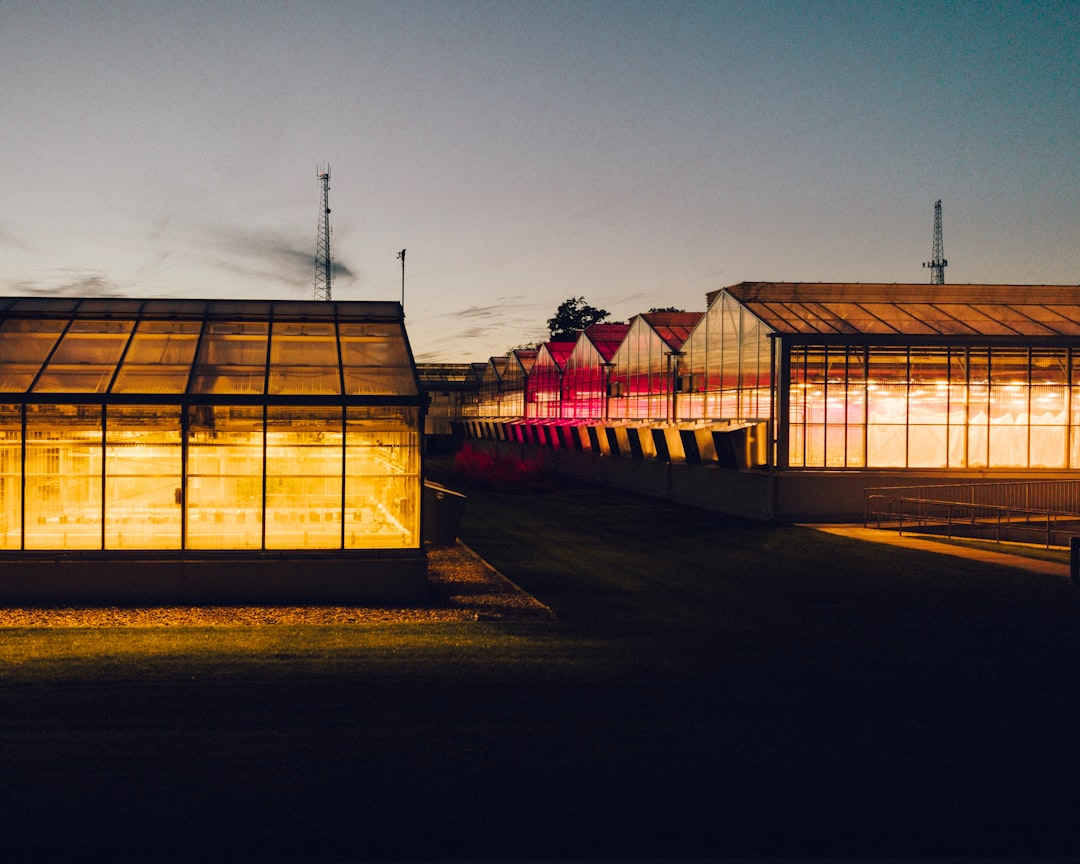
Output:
top-left (0, 550), bottom-right (428, 606)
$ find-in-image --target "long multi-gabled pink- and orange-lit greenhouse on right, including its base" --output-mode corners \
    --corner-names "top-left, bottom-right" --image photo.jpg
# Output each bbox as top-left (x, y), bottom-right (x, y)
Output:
top-left (460, 282), bottom-right (1080, 519)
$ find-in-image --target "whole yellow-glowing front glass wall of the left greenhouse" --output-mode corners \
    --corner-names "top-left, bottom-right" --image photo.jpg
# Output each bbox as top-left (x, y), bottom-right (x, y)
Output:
top-left (0, 405), bottom-right (420, 550)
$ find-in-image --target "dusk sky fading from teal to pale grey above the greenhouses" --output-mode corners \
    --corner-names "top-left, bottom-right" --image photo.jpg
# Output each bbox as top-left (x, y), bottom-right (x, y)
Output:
top-left (0, 0), bottom-right (1080, 362)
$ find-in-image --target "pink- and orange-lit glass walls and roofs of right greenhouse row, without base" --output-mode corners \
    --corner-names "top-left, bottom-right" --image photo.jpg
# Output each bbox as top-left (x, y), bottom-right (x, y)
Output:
top-left (460, 283), bottom-right (1080, 471)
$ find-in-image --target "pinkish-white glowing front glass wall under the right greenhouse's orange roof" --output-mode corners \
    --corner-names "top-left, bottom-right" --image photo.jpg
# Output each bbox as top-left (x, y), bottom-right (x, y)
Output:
top-left (788, 346), bottom-right (1080, 469)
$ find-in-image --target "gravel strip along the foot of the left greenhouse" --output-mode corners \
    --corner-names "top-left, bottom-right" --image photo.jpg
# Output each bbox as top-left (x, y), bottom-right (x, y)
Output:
top-left (0, 543), bottom-right (555, 627)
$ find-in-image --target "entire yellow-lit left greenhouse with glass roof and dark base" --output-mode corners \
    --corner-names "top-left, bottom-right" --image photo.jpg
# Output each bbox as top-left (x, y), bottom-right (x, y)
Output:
top-left (0, 298), bottom-right (427, 598)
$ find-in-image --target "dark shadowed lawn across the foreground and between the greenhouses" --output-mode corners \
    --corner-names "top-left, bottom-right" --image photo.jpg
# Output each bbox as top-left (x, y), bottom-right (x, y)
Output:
top-left (0, 475), bottom-right (1080, 861)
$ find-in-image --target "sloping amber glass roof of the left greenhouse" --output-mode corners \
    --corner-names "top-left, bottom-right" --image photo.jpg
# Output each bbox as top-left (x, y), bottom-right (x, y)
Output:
top-left (0, 297), bottom-right (419, 396)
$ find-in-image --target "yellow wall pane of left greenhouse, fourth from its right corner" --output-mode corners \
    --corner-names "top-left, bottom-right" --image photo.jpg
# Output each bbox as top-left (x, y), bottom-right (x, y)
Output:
top-left (105, 405), bottom-right (183, 549)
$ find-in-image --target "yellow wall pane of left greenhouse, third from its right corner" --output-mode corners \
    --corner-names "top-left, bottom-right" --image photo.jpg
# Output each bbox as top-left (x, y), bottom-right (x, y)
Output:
top-left (185, 405), bottom-right (262, 549)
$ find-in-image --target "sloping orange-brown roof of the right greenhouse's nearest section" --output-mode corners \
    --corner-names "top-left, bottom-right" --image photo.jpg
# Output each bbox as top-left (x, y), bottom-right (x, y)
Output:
top-left (710, 282), bottom-right (1080, 338)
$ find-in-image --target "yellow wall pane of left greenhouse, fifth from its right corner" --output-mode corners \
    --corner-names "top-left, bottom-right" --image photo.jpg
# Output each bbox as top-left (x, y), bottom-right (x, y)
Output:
top-left (25, 405), bottom-right (102, 549)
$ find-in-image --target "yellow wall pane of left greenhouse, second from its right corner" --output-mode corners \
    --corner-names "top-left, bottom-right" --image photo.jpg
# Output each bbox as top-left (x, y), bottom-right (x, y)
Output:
top-left (266, 407), bottom-right (342, 549)
